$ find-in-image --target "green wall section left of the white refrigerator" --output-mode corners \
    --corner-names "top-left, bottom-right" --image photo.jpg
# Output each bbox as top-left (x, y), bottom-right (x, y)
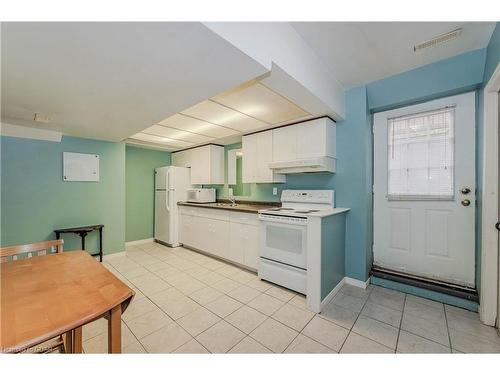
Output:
top-left (125, 145), bottom-right (170, 242)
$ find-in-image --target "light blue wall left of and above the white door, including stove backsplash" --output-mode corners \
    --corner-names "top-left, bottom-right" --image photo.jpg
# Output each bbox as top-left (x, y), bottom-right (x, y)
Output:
top-left (210, 45), bottom-right (499, 290)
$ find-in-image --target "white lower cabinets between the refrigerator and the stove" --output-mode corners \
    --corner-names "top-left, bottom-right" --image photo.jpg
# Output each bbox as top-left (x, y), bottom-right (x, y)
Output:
top-left (179, 206), bottom-right (259, 270)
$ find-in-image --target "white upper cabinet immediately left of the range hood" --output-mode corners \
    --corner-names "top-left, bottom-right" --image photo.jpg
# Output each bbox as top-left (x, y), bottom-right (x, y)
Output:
top-left (242, 130), bottom-right (286, 183)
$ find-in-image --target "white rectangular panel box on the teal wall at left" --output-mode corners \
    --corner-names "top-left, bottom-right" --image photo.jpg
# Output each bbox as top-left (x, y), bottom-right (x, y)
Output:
top-left (63, 152), bottom-right (99, 182)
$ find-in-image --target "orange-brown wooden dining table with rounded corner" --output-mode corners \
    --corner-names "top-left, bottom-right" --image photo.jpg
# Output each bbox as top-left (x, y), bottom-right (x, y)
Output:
top-left (0, 250), bottom-right (134, 353)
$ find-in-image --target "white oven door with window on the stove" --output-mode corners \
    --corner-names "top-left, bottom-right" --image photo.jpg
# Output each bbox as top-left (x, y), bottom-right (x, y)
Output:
top-left (260, 215), bottom-right (307, 269)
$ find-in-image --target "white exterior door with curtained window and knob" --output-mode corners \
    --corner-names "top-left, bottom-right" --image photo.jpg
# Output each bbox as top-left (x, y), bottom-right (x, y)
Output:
top-left (373, 92), bottom-right (476, 287)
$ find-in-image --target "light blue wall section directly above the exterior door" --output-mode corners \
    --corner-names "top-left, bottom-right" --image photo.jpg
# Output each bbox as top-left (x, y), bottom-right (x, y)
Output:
top-left (366, 48), bottom-right (486, 112)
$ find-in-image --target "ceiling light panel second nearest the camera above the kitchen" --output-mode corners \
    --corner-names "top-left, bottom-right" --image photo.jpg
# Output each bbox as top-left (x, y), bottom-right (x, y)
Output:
top-left (182, 100), bottom-right (267, 132)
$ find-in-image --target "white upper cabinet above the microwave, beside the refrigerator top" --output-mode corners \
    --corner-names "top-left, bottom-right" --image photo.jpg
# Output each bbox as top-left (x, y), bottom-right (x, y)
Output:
top-left (172, 145), bottom-right (224, 185)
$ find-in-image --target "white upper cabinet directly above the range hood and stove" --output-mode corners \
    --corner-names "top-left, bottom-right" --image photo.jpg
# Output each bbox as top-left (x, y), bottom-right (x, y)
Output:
top-left (272, 117), bottom-right (336, 162)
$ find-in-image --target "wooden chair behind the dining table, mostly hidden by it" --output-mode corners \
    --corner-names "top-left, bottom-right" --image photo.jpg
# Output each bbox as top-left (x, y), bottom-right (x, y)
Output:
top-left (0, 240), bottom-right (82, 353)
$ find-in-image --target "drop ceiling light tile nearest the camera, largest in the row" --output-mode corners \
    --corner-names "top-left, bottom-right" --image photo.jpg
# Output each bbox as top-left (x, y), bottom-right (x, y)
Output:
top-left (212, 83), bottom-right (309, 124)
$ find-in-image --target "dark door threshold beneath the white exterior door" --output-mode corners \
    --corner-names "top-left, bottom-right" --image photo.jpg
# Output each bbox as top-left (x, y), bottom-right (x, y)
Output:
top-left (370, 266), bottom-right (479, 303)
